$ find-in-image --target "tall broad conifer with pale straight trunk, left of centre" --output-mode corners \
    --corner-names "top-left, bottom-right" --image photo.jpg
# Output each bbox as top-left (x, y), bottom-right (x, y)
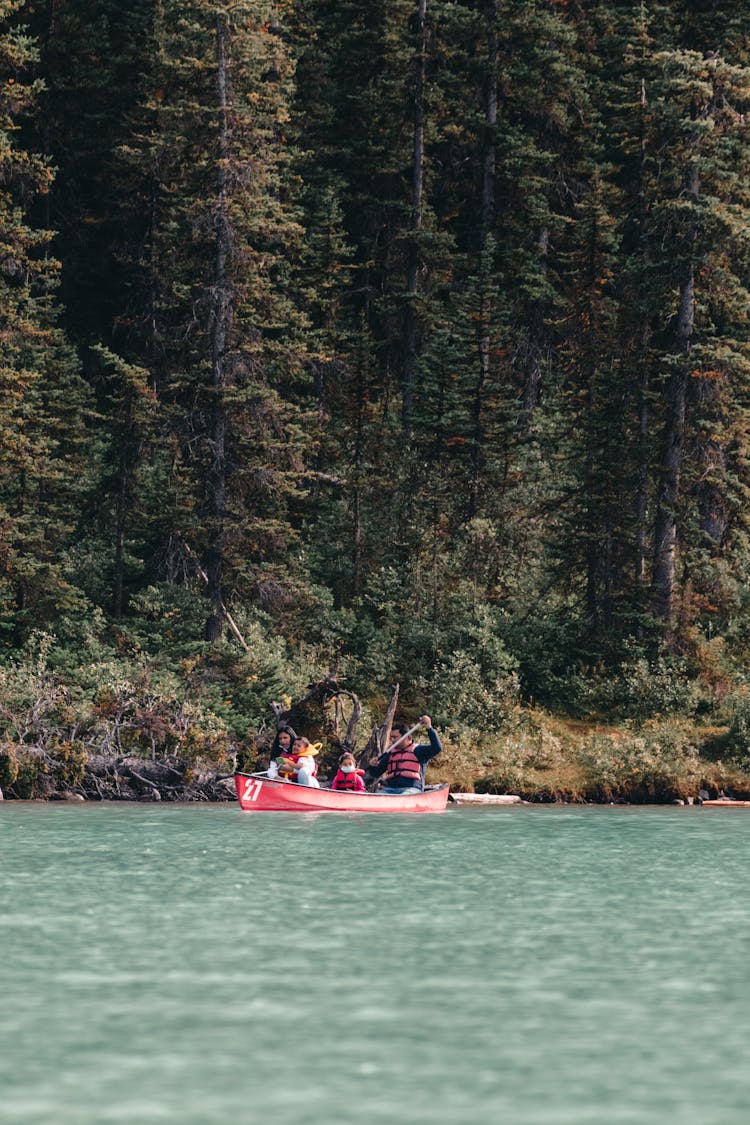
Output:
top-left (112, 0), bottom-right (307, 640)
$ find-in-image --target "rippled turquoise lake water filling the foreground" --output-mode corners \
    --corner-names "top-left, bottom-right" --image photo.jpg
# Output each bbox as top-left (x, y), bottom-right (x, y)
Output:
top-left (0, 802), bottom-right (750, 1125)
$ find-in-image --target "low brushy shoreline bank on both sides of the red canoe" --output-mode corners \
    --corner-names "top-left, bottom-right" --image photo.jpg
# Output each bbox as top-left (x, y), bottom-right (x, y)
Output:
top-left (5, 731), bottom-right (750, 807)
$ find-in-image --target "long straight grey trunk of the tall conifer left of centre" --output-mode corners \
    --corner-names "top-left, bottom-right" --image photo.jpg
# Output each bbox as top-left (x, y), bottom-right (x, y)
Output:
top-left (206, 14), bottom-right (234, 641)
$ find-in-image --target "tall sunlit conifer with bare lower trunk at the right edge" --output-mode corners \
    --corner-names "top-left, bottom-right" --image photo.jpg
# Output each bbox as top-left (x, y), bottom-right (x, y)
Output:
top-left (620, 41), bottom-right (750, 633)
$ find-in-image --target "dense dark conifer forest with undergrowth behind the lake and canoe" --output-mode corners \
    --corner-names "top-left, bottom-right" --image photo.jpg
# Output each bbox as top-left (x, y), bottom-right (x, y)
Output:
top-left (0, 0), bottom-right (750, 799)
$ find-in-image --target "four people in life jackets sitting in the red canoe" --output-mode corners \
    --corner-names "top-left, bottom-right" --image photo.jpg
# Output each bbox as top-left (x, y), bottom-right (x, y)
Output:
top-left (268, 714), bottom-right (443, 797)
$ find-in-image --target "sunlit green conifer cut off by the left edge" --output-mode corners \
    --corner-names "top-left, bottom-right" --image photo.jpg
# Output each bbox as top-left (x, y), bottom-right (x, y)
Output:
top-left (0, 0), bottom-right (92, 642)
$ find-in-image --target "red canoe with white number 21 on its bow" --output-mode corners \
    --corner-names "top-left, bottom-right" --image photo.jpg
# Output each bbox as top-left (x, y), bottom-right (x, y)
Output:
top-left (234, 774), bottom-right (449, 812)
